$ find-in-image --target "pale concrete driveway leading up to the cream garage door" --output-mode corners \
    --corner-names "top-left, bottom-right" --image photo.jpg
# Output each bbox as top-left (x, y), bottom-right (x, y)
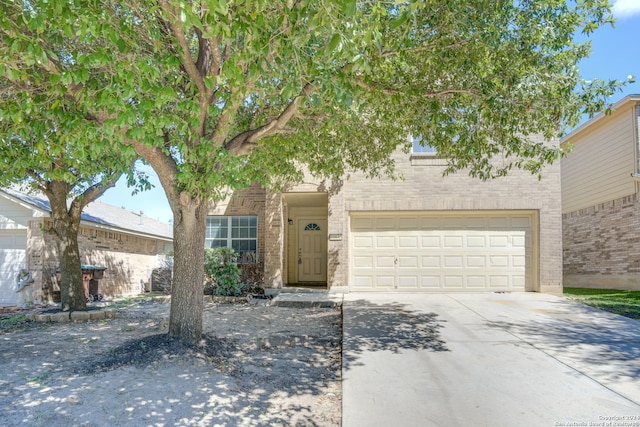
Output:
top-left (343, 293), bottom-right (640, 427)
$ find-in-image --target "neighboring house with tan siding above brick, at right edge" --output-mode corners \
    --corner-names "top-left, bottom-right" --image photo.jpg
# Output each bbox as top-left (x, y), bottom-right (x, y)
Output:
top-left (561, 95), bottom-right (640, 290)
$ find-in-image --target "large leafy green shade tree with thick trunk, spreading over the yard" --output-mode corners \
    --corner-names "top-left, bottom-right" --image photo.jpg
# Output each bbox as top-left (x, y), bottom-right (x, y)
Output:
top-left (0, 0), bottom-right (628, 342)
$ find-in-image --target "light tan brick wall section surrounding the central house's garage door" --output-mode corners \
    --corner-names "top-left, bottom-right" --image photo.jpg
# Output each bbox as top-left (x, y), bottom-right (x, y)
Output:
top-left (282, 140), bottom-right (562, 294)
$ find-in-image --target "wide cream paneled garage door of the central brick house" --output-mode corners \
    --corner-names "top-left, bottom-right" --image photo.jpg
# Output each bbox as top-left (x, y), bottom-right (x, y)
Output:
top-left (350, 211), bottom-right (537, 292)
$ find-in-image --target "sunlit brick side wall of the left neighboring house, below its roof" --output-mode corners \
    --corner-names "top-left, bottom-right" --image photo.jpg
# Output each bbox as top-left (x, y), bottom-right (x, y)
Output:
top-left (27, 220), bottom-right (171, 300)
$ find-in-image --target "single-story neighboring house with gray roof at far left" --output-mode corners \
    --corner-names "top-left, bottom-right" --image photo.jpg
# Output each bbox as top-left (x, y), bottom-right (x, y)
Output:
top-left (0, 190), bottom-right (173, 305)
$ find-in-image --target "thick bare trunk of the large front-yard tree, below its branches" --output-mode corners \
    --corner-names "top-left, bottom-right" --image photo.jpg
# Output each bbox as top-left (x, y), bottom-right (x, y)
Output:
top-left (169, 194), bottom-right (207, 344)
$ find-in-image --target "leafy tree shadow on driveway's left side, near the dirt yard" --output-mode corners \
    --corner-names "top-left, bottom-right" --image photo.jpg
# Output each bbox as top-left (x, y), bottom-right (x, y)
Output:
top-left (343, 300), bottom-right (449, 369)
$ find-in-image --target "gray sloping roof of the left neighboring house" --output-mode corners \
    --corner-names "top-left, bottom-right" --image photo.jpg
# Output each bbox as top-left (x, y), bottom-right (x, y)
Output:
top-left (0, 188), bottom-right (173, 240)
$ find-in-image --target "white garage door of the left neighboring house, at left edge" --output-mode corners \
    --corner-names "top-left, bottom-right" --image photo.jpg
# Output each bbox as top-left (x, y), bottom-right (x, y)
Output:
top-left (0, 230), bottom-right (27, 305)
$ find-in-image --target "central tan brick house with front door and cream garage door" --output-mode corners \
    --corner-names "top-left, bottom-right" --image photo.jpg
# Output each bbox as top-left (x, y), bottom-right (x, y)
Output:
top-left (206, 135), bottom-right (562, 294)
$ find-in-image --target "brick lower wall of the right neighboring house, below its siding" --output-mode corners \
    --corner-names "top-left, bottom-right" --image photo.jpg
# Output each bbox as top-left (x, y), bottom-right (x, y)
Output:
top-left (562, 194), bottom-right (640, 289)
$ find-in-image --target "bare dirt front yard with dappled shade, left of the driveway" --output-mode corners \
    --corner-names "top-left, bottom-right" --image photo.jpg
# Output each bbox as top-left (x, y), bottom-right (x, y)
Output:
top-left (0, 301), bottom-right (342, 427)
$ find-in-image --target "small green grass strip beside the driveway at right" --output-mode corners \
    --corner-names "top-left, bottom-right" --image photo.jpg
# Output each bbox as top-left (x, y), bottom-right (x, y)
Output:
top-left (564, 288), bottom-right (640, 320)
